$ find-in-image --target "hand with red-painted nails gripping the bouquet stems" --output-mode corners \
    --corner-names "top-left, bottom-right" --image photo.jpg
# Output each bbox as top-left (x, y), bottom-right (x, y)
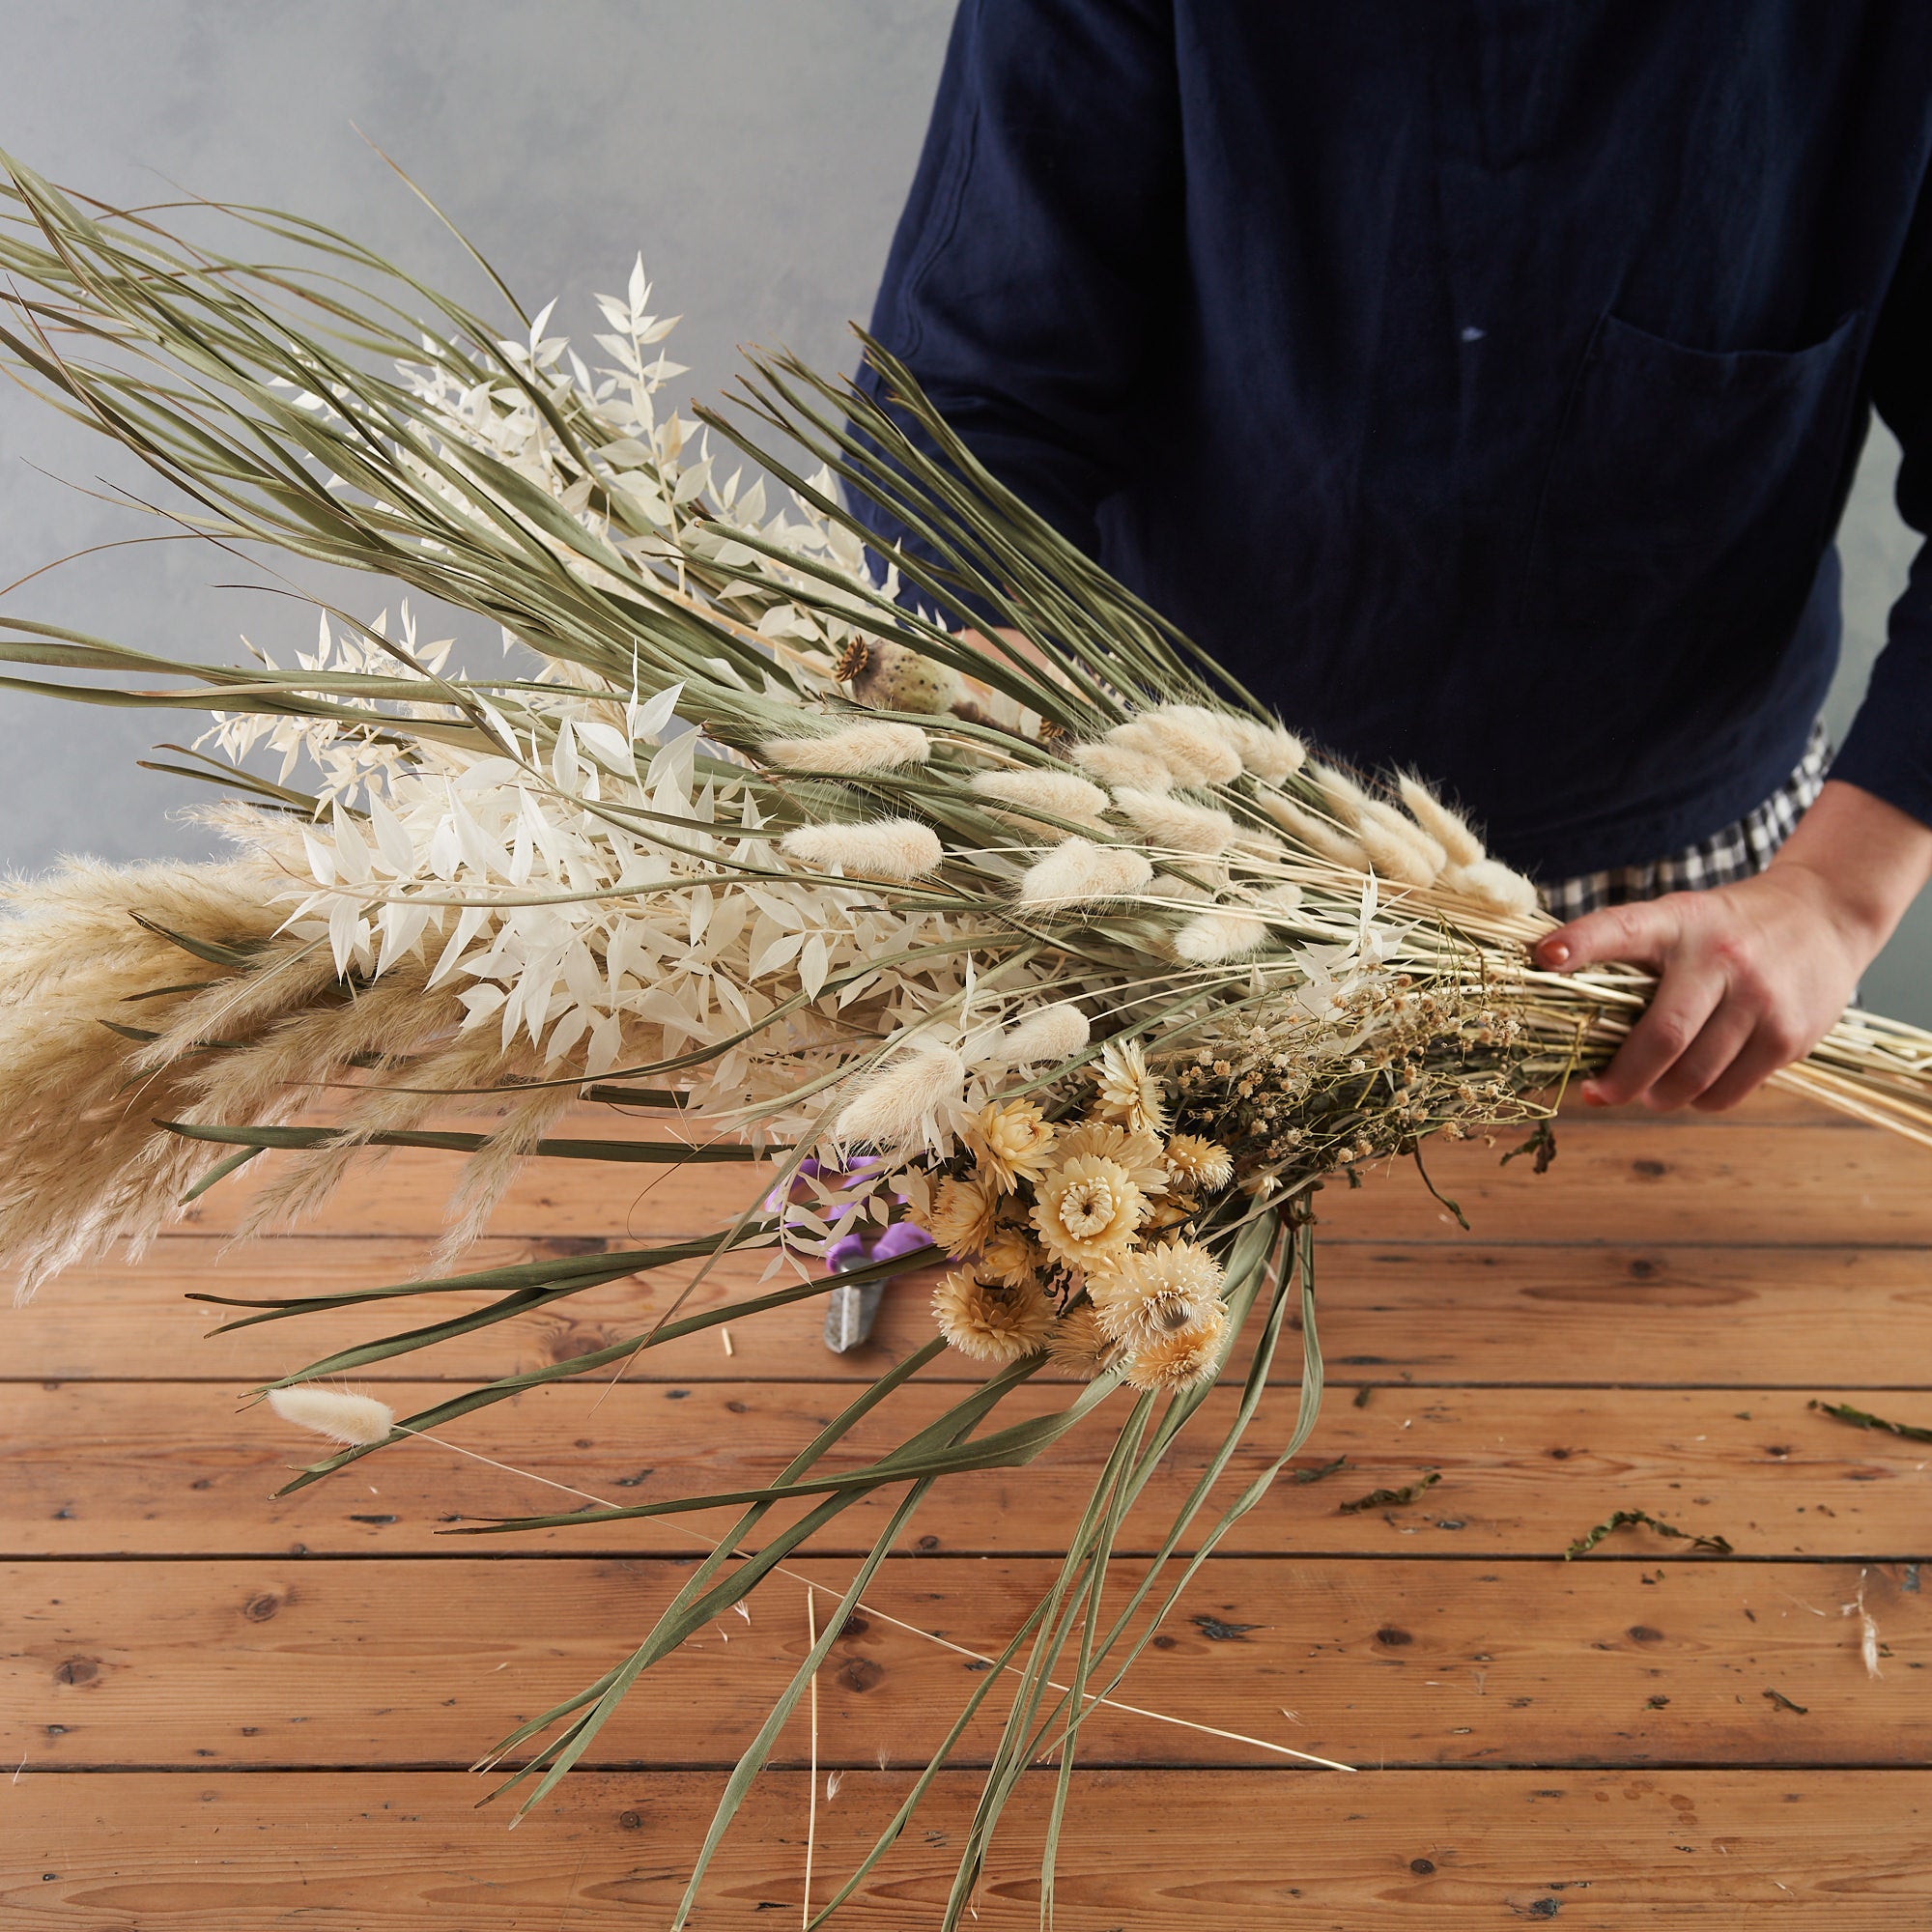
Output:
top-left (1534, 781), bottom-right (1932, 1113)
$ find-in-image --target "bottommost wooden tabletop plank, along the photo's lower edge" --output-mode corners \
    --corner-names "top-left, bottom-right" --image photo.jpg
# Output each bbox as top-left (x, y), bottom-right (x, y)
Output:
top-left (0, 1766), bottom-right (1932, 1932)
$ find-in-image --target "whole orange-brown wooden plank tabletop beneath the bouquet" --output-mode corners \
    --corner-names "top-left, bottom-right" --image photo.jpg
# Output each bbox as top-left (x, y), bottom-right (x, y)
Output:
top-left (0, 1103), bottom-right (1932, 1932)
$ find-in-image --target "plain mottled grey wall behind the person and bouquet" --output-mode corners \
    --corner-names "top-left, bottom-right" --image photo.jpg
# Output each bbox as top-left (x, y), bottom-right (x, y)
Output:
top-left (0, 0), bottom-right (1932, 1024)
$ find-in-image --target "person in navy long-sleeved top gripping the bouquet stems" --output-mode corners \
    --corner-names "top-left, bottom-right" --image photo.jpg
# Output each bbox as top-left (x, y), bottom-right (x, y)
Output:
top-left (862, 0), bottom-right (1932, 1109)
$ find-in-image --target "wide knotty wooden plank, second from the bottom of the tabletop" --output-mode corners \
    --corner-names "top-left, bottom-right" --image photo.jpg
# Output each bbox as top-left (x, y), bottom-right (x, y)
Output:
top-left (0, 1557), bottom-right (1932, 1770)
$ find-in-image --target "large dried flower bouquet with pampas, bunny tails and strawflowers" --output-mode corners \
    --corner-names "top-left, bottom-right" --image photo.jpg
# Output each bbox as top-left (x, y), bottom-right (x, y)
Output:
top-left (11, 166), bottom-right (1932, 1928)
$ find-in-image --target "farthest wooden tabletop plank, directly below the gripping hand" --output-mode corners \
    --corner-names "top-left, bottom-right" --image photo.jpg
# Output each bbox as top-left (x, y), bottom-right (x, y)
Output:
top-left (151, 1119), bottom-right (1932, 1246)
